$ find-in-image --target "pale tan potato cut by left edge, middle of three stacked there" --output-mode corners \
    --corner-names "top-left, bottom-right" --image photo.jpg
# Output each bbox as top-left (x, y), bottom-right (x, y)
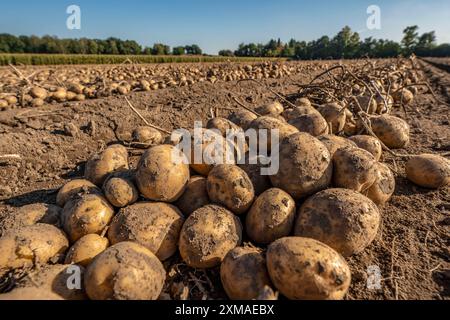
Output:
top-left (0, 223), bottom-right (69, 276)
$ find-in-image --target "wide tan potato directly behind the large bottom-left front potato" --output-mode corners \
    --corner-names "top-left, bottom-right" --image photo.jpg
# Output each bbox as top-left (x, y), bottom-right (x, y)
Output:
top-left (108, 202), bottom-right (184, 260)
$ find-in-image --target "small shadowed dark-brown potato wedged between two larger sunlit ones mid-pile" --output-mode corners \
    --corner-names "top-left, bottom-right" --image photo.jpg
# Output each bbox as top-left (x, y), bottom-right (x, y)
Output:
top-left (176, 176), bottom-right (210, 216)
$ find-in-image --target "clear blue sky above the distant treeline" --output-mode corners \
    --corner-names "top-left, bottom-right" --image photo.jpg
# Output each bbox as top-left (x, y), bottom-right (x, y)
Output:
top-left (0, 0), bottom-right (450, 54)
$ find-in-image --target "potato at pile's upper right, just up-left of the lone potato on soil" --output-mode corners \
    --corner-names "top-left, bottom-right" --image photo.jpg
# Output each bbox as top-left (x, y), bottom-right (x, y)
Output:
top-left (370, 114), bottom-right (409, 149)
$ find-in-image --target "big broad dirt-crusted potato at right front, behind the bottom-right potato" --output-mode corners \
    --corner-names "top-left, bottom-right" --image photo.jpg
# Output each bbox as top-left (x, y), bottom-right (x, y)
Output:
top-left (294, 188), bottom-right (381, 257)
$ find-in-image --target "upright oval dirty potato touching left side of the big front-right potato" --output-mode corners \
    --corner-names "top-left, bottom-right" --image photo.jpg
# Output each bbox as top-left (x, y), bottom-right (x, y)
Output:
top-left (245, 188), bottom-right (295, 244)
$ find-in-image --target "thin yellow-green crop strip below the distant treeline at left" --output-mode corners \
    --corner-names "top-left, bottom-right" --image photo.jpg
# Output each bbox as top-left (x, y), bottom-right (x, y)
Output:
top-left (0, 54), bottom-right (286, 66)
